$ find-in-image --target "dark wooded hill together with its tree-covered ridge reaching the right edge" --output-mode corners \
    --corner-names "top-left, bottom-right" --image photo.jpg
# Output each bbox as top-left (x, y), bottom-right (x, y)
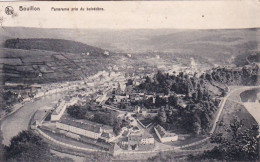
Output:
top-left (135, 65), bottom-right (259, 135)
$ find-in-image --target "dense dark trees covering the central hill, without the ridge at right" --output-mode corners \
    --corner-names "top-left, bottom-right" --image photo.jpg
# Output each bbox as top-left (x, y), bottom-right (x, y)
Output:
top-left (136, 71), bottom-right (219, 134)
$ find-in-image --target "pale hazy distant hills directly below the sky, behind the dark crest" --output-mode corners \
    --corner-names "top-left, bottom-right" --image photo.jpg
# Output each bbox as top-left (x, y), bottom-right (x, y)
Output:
top-left (0, 28), bottom-right (260, 65)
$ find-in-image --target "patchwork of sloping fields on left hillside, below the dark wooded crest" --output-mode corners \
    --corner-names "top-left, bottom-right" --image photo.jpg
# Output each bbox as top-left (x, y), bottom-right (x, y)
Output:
top-left (0, 40), bottom-right (117, 84)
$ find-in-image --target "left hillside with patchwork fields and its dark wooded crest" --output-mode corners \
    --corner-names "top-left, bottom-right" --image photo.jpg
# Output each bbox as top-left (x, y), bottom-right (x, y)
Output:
top-left (0, 39), bottom-right (117, 84)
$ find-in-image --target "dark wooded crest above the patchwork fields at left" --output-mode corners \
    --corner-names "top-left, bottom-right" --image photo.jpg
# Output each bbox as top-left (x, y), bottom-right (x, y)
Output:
top-left (4, 38), bottom-right (105, 55)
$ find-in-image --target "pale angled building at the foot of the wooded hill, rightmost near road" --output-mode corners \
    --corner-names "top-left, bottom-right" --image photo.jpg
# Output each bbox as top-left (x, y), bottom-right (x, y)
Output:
top-left (154, 124), bottom-right (178, 143)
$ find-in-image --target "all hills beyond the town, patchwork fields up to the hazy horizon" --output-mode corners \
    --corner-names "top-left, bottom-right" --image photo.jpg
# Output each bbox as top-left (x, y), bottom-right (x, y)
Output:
top-left (0, 27), bottom-right (260, 85)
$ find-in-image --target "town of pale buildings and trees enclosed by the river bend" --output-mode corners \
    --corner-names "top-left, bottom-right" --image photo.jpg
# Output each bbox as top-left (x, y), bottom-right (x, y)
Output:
top-left (25, 57), bottom-right (255, 155)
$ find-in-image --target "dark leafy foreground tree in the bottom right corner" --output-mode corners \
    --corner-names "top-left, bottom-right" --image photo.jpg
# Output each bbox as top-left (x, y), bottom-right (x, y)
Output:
top-left (196, 117), bottom-right (259, 161)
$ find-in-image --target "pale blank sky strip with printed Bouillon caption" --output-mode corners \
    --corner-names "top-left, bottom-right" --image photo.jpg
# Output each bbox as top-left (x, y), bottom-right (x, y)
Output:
top-left (0, 0), bottom-right (260, 29)
